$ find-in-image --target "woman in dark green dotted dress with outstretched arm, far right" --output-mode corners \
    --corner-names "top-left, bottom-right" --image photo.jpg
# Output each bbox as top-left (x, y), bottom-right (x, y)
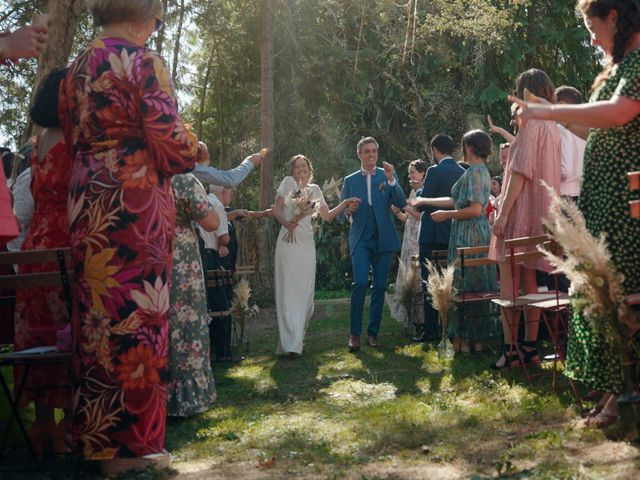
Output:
top-left (514, 0), bottom-right (640, 427)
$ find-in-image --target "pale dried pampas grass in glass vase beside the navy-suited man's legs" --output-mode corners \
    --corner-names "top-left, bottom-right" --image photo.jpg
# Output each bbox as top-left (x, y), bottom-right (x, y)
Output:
top-left (424, 260), bottom-right (455, 358)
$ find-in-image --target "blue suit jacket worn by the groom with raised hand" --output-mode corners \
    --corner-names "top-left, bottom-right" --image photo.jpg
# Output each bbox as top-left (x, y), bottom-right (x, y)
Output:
top-left (340, 167), bottom-right (407, 255)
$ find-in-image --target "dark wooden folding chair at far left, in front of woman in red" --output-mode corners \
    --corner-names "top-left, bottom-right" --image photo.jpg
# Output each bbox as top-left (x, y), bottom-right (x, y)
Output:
top-left (0, 248), bottom-right (73, 458)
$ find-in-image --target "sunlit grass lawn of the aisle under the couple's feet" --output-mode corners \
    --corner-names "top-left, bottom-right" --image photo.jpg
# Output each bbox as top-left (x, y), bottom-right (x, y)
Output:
top-left (1, 299), bottom-right (640, 480)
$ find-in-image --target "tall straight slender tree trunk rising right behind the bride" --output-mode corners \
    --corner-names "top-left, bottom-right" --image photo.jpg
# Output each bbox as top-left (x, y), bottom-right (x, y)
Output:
top-left (255, 0), bottom-right (274, 303)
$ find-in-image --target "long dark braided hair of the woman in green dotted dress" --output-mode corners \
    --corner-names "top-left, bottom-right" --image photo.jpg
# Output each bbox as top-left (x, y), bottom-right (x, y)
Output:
top-left (578, 0), bottom-right (640, 90)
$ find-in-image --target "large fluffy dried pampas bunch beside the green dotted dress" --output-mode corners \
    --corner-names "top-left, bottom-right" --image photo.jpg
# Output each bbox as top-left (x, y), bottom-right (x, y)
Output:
top-left (540, 182), bottom-right (640, 350)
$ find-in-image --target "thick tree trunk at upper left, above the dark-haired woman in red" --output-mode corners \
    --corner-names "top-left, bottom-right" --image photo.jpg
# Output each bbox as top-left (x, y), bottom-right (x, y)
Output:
top-left (20, 0), bottom-right (85, 145)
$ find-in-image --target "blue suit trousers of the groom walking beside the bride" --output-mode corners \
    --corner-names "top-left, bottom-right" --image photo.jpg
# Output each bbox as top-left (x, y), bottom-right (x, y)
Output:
top-left (351, 239), bottom-right (393, 337)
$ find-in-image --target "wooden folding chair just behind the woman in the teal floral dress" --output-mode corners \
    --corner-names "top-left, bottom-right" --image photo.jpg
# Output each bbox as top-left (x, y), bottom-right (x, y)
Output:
top-left (453, 246), bottom-right (500, 346)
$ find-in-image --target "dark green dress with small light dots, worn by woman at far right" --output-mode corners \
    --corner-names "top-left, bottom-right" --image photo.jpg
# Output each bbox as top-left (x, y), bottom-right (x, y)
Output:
top-left (566, 49), bottom-right (640, 393)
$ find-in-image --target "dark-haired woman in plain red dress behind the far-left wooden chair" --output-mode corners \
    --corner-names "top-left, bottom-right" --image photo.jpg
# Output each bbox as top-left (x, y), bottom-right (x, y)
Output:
top-left (14, 69), bottom-right (71, 453)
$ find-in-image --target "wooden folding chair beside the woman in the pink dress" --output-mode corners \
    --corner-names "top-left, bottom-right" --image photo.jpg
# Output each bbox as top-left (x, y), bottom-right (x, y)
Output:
top-left (492, 235), bottom-right (570, 391)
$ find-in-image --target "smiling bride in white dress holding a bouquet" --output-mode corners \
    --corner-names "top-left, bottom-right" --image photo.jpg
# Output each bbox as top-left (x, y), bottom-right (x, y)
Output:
top-left (274, 155), bottom-right (359, 358)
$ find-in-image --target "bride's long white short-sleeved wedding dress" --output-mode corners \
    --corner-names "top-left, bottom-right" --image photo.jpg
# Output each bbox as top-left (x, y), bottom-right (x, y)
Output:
top-left (275, 177), bottom-right (325, 355)
